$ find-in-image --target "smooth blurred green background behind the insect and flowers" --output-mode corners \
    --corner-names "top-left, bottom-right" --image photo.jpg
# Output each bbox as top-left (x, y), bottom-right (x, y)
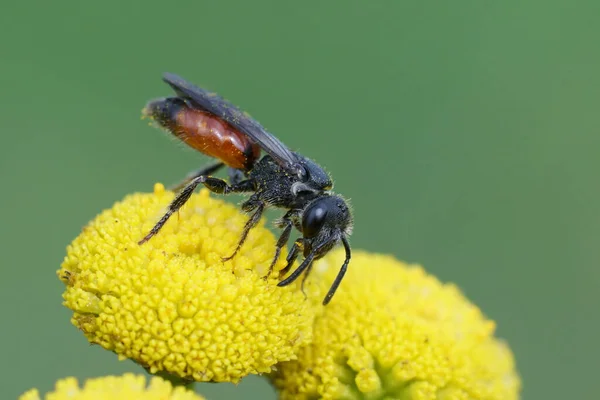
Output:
top-left (0, 0), bottom-right (600, 399)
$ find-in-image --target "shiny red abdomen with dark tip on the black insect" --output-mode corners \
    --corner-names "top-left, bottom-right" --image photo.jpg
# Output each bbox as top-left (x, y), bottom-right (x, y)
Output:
top-left (144, 98), bottom-right (260, 170)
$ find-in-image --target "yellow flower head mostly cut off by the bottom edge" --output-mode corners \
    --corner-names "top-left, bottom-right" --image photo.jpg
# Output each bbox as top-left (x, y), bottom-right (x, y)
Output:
top-left (19, 374), bottom-right (204, 400)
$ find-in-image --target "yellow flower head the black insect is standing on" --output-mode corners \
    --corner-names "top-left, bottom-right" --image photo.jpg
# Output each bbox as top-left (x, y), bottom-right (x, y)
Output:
top-left (57, 184), bottom-right (316, 382)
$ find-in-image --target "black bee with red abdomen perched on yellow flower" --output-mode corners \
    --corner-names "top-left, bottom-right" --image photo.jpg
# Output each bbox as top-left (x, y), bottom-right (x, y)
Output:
top-left (139, 73), bottom-right (353, 305)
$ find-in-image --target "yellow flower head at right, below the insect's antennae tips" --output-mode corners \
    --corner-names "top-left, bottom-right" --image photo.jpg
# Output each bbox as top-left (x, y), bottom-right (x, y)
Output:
top-left (271, 251), bottom-right (520, 400)
